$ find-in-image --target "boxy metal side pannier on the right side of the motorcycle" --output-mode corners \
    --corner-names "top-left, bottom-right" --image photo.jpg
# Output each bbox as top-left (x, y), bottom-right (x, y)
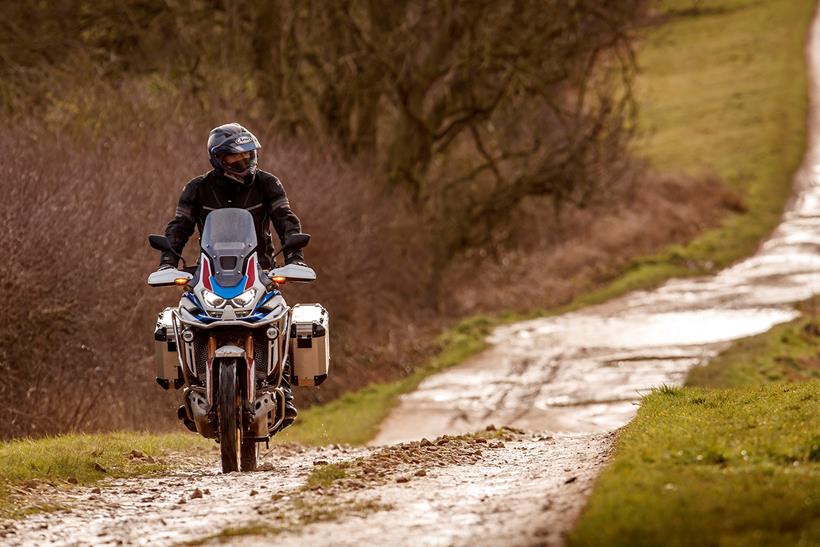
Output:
top-left (290, 304), bottom-right (330, 386)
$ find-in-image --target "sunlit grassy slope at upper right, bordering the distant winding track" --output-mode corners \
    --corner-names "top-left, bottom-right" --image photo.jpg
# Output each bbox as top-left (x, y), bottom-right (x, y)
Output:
top-left (574, 0), bottom-right (815, 307)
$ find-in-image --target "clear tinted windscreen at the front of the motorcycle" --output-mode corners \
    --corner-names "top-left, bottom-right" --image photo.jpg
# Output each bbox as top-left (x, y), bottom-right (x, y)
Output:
top-left (201, 209), bottom-right (257, 287)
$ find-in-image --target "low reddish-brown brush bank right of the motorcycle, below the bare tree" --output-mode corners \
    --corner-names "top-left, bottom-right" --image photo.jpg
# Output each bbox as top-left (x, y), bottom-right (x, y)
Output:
top-left (439, 170), bottom-right (742, 314)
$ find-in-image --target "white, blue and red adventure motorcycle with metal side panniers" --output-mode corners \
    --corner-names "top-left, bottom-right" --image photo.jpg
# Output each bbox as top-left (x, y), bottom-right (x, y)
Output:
top-left (148, 209), bottom-right (329, 473)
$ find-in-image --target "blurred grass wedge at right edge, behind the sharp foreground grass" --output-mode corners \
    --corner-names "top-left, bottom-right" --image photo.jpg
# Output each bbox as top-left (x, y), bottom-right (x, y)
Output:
top-left (686, 299), bottom-right (820, 388)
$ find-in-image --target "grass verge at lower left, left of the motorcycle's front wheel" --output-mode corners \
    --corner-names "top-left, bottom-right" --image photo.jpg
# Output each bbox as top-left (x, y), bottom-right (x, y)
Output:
top-left (0, 432), bottom-right (212, 517)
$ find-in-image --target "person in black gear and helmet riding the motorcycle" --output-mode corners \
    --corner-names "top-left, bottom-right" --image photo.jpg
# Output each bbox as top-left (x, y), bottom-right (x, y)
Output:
top-left (160, 123), bottom-right (304, 425)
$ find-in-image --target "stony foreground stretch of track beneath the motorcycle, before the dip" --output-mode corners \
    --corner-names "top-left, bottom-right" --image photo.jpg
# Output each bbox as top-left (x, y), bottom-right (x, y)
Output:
top-left (2, 429), bottom-right (611, 546)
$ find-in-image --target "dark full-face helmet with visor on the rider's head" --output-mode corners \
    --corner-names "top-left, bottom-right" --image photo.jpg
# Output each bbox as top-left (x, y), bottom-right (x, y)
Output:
top-left (208, 123), bottom-right (262, 183)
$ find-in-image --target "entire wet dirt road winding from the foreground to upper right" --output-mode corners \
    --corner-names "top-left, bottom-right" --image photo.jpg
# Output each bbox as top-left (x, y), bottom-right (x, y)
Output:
top-left (0, 9), bottom-right (820, 545)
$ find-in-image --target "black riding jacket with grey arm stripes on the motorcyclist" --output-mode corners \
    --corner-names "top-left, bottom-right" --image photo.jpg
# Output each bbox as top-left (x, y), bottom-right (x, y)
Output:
top-left (160, 170), bottom-right (304, 269)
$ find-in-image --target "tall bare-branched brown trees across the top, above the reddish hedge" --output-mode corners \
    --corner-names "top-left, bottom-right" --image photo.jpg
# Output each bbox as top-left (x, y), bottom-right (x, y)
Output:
top-left (0, 0), bottom-right (648, 270)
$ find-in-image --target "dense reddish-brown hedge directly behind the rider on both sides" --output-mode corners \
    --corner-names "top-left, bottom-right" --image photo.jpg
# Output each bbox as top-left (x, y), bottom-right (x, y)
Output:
top-left (0, 124), bottom-right (435, 437)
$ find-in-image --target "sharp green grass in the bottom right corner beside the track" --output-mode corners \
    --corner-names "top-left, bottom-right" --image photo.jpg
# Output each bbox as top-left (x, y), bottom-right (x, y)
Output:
top-left (570, 381), bottom-right (820, 547)
